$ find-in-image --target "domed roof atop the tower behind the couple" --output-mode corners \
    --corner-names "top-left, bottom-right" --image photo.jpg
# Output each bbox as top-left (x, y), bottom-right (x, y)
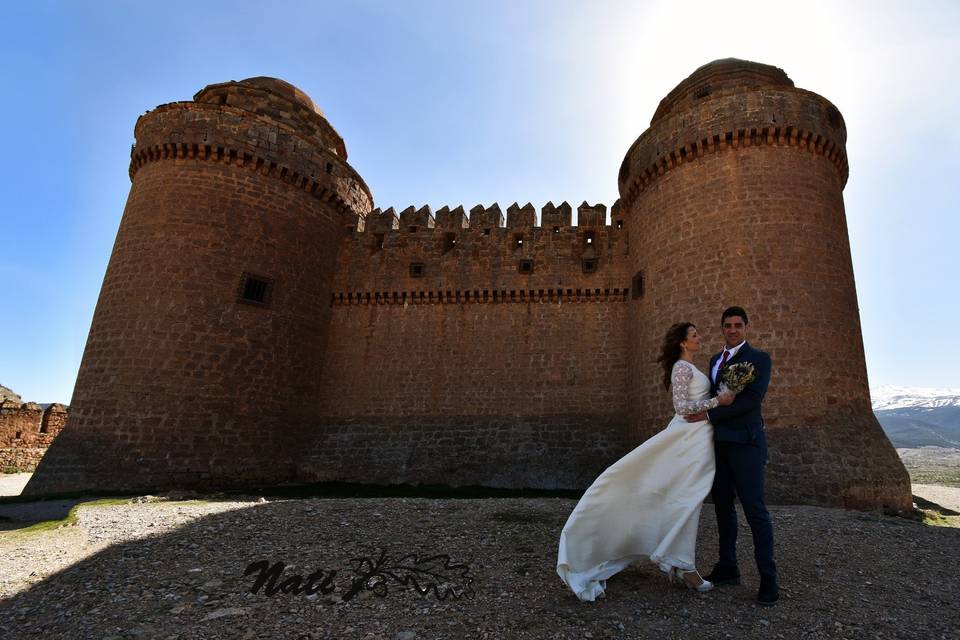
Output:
top-left (650, 58), bottom-right (793, 125)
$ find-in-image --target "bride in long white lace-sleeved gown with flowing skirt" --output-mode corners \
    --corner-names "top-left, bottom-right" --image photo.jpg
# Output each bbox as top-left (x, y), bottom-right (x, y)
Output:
top-left (557, 322), bottom-right (734, 602)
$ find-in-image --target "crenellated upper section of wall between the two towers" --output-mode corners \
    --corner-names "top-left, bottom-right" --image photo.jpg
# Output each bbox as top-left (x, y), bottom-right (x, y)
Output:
top-left (333, 202), bottom-right (630, 304)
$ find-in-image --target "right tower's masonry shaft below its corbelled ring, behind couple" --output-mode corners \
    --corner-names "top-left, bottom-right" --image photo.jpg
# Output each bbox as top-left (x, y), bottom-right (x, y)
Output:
top-left (631, 147), bottom-right (909, 506)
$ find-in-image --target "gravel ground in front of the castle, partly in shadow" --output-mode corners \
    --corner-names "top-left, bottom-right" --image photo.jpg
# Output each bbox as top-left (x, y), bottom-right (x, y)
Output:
top-left (0, 498), bottom-right (960, 640)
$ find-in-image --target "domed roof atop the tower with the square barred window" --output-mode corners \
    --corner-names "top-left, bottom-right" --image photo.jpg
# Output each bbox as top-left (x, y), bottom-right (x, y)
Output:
top-left (193, 76), bottom-right (347, 160)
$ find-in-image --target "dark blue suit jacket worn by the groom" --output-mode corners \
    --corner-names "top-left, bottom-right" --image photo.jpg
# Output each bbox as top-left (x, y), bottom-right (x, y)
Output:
top-left (707, 343), bottom-right (772, 460)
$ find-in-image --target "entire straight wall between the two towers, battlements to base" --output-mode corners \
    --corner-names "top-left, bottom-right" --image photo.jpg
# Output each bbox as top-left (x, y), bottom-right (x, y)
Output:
top-left (300, 203), bottom-right (629, 488)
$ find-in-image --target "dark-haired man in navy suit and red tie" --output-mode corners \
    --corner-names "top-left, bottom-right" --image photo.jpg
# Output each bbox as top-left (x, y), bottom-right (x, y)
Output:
top-left (686, 307), bottom-right (779, 605)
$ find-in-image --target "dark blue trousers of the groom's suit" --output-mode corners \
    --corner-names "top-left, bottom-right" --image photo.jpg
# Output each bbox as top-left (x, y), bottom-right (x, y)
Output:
top-left (712, 442), bottom-right (777, 578)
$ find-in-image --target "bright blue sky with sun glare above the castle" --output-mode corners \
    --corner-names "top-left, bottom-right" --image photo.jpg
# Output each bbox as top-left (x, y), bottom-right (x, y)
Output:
top-left (0, 0), bottom-right (960, 403)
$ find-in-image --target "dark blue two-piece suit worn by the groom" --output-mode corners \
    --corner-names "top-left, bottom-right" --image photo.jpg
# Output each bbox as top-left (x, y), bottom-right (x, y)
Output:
top-left (707, 343), bottom-right (777, 578)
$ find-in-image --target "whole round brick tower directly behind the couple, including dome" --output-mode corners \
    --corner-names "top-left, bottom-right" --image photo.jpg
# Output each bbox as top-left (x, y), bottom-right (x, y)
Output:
top-left (619, 59), bottom-right (911, 508)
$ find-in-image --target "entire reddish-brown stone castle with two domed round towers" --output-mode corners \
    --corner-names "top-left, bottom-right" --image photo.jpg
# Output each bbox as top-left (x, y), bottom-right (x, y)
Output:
top-left (25, 59), bottom-right (911, 509)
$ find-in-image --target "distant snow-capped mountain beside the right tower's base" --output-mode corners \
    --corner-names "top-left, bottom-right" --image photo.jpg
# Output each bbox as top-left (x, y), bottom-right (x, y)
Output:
top-left (870, 385), bottom-right (960, 449)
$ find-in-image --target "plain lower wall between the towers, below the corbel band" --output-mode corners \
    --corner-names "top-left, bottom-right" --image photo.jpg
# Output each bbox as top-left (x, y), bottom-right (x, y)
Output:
top-left (310, 295), bottom-right (631, 488)
